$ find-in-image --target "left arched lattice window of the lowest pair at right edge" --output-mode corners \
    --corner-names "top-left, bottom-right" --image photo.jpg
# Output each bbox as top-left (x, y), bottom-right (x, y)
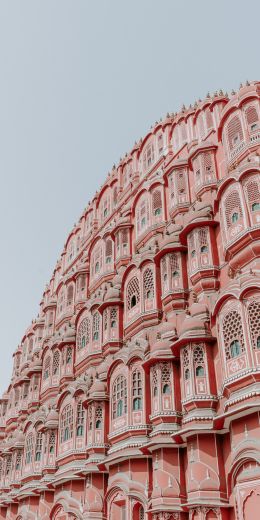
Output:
top-left (222, 310), bottom-right (245, 359)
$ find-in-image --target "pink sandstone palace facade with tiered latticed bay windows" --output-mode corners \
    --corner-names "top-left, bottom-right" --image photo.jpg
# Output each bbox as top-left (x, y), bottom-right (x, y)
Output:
top-left (0, 81), bottom-right (260, 520)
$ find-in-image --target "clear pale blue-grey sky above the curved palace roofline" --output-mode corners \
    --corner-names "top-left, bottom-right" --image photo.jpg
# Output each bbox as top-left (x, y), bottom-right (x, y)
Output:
top-left (0, 0), bottom-right (260, 392)
